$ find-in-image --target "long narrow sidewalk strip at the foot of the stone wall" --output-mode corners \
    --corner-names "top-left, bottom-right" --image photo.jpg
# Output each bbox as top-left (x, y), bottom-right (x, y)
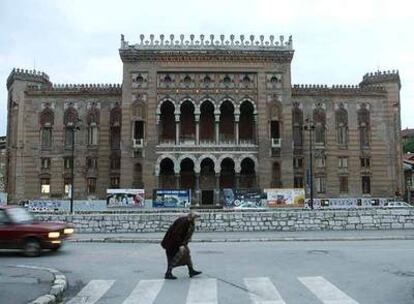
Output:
top-left (68, 229), bottom-right (414, 243)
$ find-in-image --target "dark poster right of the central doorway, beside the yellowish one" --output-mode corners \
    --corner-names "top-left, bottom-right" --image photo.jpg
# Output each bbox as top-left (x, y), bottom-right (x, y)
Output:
top-left (219, 188), bottom-right (263, 208)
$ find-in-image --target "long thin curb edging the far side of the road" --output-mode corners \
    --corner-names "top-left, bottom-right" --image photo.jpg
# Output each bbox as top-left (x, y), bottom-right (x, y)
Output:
top-left (67, 236), bottom-right (414, 244)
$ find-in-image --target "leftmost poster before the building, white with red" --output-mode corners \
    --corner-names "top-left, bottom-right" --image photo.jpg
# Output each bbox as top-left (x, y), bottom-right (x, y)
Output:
top-left (106, 189), bottom-right (145, 207)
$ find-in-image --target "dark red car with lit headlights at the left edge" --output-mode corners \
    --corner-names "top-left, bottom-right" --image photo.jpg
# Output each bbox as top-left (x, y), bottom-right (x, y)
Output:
top-left (0, 206), bottom-right (74, 257)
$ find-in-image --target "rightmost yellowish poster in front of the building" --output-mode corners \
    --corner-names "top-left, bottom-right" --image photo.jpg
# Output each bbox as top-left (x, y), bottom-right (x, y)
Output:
top-left (264, 188), bottom-right (305, 208)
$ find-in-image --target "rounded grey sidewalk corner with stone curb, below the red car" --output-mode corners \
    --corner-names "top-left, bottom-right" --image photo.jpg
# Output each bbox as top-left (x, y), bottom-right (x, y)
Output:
top-left (0, 265), bottom-right (67, 304)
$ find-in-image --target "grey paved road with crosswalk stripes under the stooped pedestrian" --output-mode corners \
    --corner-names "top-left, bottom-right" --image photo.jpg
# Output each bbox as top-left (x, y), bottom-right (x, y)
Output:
top-left (0, 240), bottom-right (414, 304)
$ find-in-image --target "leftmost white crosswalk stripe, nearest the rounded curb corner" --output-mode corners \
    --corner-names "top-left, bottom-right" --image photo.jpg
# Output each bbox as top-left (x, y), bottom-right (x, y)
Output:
top-left (66, 280), bottom-right (115, 304)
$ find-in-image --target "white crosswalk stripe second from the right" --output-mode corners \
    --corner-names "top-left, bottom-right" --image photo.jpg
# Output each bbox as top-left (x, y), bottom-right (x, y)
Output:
top-left (244, 278), bottom-right (286, 304)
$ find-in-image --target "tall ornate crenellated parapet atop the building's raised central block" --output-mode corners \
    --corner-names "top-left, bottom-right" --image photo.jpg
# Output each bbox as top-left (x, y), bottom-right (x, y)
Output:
top-left (119, 34), bottom-right (293, 62)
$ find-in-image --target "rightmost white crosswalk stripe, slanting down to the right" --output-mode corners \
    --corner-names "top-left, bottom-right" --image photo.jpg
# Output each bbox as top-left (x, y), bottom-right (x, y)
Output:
top-left (298, 277), bottom-right (358, 304)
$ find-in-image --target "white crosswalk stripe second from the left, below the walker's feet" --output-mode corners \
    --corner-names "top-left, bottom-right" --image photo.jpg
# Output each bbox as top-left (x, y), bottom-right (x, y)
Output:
top-left (122, 280), bottom-right (164, 304)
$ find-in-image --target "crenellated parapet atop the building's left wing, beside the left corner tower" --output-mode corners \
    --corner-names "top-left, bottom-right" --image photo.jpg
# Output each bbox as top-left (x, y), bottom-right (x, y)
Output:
top-left (26, 84), bottom-right (122, 95)
